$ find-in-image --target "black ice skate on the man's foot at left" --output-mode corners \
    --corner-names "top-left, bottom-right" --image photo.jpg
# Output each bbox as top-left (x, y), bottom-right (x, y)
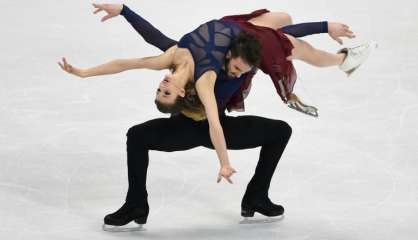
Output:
top-left (103, 203), bottom-right (149, 232)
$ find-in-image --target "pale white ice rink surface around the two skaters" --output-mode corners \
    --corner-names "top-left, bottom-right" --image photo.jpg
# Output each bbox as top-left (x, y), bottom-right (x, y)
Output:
top-left (0, 0), bottom-right (418, 240)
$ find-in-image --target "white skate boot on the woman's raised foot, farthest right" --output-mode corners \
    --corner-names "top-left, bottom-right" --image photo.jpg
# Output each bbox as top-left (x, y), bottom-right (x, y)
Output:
top-left (338, 42), bottom-right (378, 76)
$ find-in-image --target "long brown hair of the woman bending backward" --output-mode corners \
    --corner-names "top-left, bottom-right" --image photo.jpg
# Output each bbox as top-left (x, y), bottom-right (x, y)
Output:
top-left (155, 82), bottom-right (203, 115)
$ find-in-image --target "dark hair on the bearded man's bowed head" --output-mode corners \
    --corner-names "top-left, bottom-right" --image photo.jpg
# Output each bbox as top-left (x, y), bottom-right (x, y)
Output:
top-left (231, 32), bottom-right (261, 67)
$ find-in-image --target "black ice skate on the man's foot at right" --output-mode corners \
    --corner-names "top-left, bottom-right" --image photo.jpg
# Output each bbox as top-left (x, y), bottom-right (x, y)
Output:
top-left (241, 196), bottom-right (284, 223)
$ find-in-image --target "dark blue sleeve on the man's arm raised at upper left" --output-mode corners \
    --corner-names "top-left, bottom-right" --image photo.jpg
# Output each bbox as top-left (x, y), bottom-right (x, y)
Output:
top-left (120, 5), bottom-right (177, 52)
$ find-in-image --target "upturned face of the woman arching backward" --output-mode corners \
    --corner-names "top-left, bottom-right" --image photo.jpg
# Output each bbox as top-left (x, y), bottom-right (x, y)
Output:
top-left (155, 72), bottom-right (185, 104)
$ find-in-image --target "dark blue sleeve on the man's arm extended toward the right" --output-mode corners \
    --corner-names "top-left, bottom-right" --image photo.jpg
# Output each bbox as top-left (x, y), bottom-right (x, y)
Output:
top-left (281, 22), bottom-right (328, 37)
